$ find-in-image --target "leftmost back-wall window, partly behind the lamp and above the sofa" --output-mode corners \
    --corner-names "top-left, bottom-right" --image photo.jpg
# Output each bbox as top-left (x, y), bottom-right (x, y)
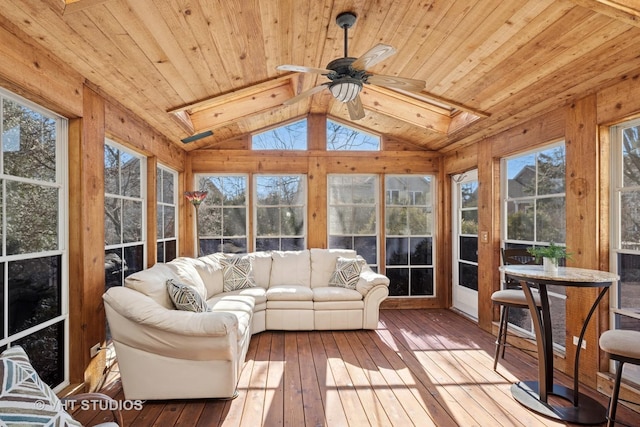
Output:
top-left (197, 175), bottom-right (248, 255)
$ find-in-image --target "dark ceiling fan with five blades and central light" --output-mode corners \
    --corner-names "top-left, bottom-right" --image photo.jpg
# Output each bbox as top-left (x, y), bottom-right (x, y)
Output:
top-left (276, 12), bottom-right (426, 120)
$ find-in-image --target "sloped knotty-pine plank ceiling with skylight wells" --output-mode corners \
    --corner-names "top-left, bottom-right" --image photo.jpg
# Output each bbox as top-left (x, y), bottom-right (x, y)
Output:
top-left (0, 0), bottom-right (640, 152)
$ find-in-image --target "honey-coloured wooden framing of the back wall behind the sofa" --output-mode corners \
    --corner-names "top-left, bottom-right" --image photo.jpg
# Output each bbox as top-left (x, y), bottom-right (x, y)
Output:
top-left (188, 120), bottom-right (448, 308)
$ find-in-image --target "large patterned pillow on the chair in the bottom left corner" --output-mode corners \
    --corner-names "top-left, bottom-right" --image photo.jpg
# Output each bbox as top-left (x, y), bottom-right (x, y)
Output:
top-left (0, 346), bottom-right (82, 426)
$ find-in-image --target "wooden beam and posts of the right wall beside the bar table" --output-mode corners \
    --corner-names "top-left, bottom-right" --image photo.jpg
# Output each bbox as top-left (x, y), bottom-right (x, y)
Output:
top-left (443, 82), bottom-right (640, 388)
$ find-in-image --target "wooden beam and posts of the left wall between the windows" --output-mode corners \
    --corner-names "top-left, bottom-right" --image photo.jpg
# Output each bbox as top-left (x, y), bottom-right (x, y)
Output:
top-left (0, 22), bottom-right (185, 389)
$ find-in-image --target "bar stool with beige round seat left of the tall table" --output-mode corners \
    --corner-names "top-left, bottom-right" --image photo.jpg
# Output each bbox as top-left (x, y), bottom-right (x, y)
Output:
top-left (491, 249), bottom-right (540, 371)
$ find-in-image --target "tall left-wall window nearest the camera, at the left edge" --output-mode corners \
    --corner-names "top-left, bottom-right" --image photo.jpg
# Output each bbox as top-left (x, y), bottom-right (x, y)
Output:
top-left (0, 90), bottom-right (69, 387)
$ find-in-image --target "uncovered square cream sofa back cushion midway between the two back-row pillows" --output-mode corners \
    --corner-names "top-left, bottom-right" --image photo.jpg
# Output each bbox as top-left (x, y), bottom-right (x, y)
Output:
top-left (269, 249), bottom-right (311, 288)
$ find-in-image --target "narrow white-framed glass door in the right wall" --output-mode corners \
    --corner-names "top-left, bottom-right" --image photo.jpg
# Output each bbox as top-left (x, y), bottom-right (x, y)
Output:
top-left (451, 170), bottom-right (478, 319)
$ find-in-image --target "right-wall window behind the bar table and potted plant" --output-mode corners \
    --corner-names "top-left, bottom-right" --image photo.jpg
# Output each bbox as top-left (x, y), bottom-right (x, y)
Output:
top-left (501, 143), bottom-right (566, 348)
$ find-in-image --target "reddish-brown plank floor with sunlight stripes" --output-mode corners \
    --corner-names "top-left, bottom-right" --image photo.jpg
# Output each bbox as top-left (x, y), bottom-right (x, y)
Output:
top-left (74, 310), bottom-right (640, 427)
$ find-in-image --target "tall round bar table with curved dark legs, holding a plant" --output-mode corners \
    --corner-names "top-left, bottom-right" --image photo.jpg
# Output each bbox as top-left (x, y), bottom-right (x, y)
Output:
top-left (500, 265), bottom-right (620, 424)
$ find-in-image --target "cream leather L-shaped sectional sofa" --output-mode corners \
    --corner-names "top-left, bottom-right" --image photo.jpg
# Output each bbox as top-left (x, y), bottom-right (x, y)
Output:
top-left (103, 249), bottom-right (389, 400)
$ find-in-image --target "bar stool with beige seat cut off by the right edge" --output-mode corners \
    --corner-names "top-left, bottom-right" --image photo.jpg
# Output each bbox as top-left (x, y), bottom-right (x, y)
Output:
top-left (600, 329), bottom-right (640, 426)
